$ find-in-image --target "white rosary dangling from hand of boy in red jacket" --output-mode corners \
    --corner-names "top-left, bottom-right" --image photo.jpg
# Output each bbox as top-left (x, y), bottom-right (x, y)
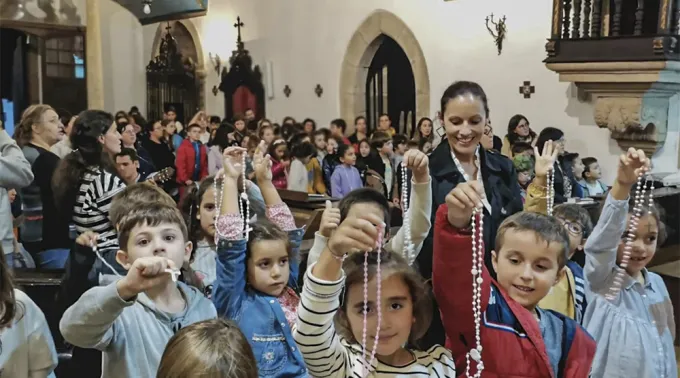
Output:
top-left (465, 209), bottom-right (484, 378)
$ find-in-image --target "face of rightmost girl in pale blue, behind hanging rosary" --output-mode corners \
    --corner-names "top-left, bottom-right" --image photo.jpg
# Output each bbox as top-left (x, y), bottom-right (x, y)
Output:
top-left (616, 214), bottom-right (659, 277)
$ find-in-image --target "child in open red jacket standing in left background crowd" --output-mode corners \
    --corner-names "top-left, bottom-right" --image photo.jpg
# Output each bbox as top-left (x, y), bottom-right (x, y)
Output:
top-left (175, 123), bottom-right (208, 198)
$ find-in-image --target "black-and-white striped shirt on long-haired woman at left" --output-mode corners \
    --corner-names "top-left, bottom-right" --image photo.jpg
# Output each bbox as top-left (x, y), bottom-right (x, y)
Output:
top-left (73, 167), bottom-right (125, 250)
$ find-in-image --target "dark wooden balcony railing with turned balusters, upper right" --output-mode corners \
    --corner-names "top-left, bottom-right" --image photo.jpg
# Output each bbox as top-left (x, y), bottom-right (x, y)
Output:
top-left (545, 0), bottom-right (680, 63)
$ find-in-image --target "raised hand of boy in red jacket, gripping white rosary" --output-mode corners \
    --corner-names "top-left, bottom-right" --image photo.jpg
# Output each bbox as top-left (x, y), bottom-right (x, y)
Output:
top-left (446, 181), bottom-right (485, 229)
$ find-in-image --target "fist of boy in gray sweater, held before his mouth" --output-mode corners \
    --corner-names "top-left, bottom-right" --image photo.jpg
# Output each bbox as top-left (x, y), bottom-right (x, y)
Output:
top-left (116, 256), bottom-right (177, 300)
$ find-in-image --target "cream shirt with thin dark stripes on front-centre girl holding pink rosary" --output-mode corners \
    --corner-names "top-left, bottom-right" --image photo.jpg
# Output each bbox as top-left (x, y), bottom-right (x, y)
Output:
top-left (293, 267), bottom-right (456, 378)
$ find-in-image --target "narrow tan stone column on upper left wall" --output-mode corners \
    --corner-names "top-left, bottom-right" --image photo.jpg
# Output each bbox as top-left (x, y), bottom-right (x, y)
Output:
top-left (85, 0), bottom-right (104, 109)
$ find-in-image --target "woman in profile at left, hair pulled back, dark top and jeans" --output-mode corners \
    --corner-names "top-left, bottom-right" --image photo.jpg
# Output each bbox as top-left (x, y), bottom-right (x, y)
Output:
top-left (14, 105), bottom-right (71, 269)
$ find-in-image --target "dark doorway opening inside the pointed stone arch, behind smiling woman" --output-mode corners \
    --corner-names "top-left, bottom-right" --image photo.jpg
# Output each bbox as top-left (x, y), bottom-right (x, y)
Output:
top-left (366, 34), bottom-right (416, 136)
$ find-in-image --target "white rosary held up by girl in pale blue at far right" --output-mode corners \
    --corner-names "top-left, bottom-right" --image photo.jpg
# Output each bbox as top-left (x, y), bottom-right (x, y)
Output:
top-left (605, 169), bottom-right (654, 302)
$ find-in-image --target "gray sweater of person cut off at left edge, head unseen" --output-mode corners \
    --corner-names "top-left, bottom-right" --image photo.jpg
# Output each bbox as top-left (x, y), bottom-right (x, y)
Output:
top-left (0, 129), bottom-right (33, 254)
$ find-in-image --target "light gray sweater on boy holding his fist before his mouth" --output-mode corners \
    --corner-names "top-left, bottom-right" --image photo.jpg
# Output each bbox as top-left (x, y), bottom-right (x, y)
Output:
top-left (59, 282), bottom-right (217, 378)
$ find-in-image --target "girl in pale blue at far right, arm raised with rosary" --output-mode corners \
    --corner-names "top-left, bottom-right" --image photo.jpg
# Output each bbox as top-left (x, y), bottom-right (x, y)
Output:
top-left (583, 148), bottom-right (678, 378)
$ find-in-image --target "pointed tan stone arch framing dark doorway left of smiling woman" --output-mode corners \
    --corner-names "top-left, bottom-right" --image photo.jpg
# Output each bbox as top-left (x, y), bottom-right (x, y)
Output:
top-left (340, 9), bottom-right (431, 131)
